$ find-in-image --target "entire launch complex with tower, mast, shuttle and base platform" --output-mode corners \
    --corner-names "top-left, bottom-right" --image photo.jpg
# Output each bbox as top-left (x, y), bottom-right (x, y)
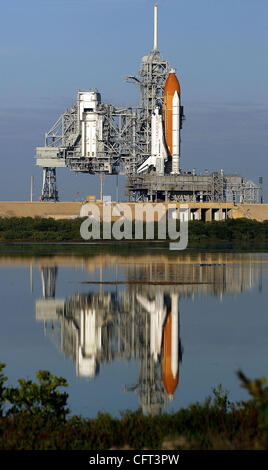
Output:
top-left (36, 5), bottom-right (262, 204)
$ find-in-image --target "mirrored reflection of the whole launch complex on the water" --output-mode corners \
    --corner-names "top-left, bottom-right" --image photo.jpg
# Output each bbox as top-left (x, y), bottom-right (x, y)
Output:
top-left (36, 254), bottom-right (266, 413)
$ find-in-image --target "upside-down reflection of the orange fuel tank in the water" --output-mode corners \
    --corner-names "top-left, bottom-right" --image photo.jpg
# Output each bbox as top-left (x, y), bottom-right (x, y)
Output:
top-left (162, 312), bottom-right (179, 395)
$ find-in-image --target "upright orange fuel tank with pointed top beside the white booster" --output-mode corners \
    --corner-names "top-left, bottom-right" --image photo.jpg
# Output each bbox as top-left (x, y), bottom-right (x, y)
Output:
top-left (164, 71), bottom-right (181, 158)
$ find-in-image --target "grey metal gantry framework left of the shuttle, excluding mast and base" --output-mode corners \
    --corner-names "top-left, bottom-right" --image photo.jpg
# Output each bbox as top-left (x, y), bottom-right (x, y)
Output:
top-left (37, 46), bottom-right (170, 185)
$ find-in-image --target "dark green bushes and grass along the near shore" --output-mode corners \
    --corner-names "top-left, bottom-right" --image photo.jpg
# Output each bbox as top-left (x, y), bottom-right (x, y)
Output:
top-left (0, 364), bottom-right (268, 450)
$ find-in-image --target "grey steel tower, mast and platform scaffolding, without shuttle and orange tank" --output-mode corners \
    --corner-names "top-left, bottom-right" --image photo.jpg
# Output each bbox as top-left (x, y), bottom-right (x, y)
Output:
top-left (36, 8), bottom-right (261, 203)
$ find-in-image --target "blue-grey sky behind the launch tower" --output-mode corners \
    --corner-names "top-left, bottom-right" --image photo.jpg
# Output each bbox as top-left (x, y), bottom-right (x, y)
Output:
top-left (0, 0), bottom-right (268, 201)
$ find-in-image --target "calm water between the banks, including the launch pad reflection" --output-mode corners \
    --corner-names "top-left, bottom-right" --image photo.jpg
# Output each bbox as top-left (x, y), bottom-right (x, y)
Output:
top-left (0, 246), bottom-right (268, 417)
